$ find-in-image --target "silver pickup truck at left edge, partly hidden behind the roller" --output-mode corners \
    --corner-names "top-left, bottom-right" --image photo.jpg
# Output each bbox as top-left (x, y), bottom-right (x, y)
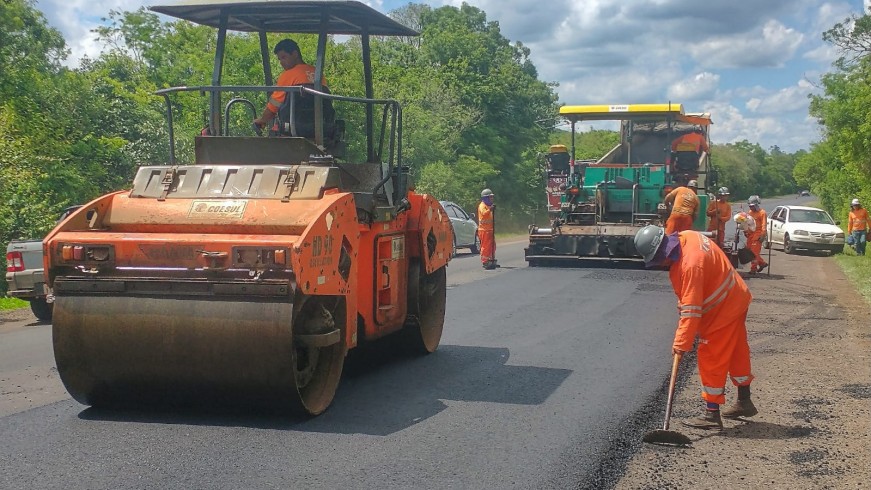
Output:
top-left (6, 206), bottom-right (80, 322)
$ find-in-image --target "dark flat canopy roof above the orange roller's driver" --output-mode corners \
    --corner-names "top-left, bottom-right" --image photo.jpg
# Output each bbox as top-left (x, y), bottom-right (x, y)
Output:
top-left (149, 0), bottom-right (418, 36)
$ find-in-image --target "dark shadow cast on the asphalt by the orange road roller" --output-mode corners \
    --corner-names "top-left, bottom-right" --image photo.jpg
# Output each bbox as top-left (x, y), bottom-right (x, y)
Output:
top-left (79, 339), bottom-right (572, 436)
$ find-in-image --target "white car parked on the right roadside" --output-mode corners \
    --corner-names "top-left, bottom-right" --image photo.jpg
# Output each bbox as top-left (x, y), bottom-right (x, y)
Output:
top-left (766, 206), bottom-right (844, 254)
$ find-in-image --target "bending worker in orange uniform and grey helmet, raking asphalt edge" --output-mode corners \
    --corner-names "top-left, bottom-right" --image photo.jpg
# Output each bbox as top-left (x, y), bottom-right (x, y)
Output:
top-left (635, 225), bottom-right (758, 429)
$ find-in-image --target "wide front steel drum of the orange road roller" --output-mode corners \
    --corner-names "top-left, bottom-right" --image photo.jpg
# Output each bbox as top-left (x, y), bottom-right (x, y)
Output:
top-left (52, 295), bottom-right (345, 414)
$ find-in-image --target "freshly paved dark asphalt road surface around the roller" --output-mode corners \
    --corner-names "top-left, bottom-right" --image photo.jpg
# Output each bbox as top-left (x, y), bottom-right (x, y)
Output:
top-left (0, 242), bottom-right (677, 489)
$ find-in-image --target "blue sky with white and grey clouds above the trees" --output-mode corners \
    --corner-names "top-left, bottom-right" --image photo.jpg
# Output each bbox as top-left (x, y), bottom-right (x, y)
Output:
top-left (37, 0), bottom-right (871, 152)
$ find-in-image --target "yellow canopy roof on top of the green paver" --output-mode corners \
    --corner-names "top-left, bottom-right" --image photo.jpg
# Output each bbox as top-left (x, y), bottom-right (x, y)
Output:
top-left (560, 104), bottom-right (713, 126)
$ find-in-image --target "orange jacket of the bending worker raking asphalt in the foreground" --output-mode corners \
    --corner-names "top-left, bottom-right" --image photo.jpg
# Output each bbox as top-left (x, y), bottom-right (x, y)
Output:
top-left (669, 230), bottom-right (753, 352)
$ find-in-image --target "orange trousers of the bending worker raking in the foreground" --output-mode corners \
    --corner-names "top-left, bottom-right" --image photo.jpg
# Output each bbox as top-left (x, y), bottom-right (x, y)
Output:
top-left (697, 310), bottom-right (753, 405)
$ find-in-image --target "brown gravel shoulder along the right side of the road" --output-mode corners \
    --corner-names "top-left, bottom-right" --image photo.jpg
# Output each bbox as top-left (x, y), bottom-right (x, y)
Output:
top-left (615, 251), bottom-right (871, 490)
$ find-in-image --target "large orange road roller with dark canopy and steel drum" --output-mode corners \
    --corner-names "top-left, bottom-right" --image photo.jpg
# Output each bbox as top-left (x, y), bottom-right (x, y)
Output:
top-left (44, 1), bottom-right (453, 414)
